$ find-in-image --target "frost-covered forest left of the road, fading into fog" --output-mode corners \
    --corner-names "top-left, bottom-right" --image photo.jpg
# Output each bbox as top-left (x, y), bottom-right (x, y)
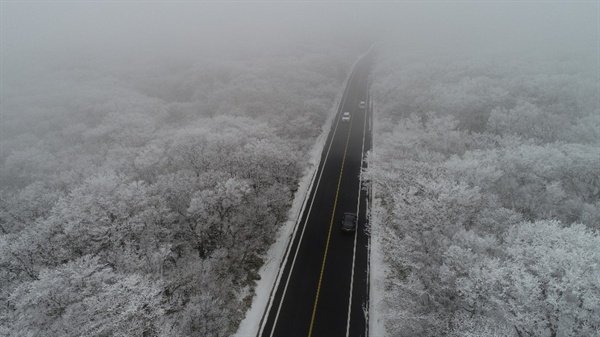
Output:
top-left (0, 40), bottom-right (362, 336)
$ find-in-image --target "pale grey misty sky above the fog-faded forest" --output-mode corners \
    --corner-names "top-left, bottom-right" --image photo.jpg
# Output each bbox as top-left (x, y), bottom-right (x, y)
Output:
top-left (1, 1), bottom-right (599, 70)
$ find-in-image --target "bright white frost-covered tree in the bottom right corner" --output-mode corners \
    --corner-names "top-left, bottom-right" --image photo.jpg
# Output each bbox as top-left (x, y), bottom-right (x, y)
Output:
top-left (444, 220), bottom-right (600, 336)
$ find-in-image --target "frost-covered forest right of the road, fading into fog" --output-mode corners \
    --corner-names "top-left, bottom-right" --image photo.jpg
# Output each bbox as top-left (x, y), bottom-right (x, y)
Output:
top-left (365, 43), bottom-right (600, 337)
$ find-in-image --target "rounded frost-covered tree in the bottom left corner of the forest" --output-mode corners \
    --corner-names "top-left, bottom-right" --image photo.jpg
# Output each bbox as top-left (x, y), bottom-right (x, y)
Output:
top-left (9, 256), bottom-right (164, 336)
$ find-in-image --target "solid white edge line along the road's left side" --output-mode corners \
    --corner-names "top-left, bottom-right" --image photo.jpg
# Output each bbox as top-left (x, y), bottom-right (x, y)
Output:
top-left (259, 65), bottom-right (356, 337)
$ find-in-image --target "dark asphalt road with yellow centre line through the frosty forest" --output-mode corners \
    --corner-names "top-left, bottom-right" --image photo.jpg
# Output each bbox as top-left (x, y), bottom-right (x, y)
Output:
top-left (259, 56), bottom-right (371, 337)
